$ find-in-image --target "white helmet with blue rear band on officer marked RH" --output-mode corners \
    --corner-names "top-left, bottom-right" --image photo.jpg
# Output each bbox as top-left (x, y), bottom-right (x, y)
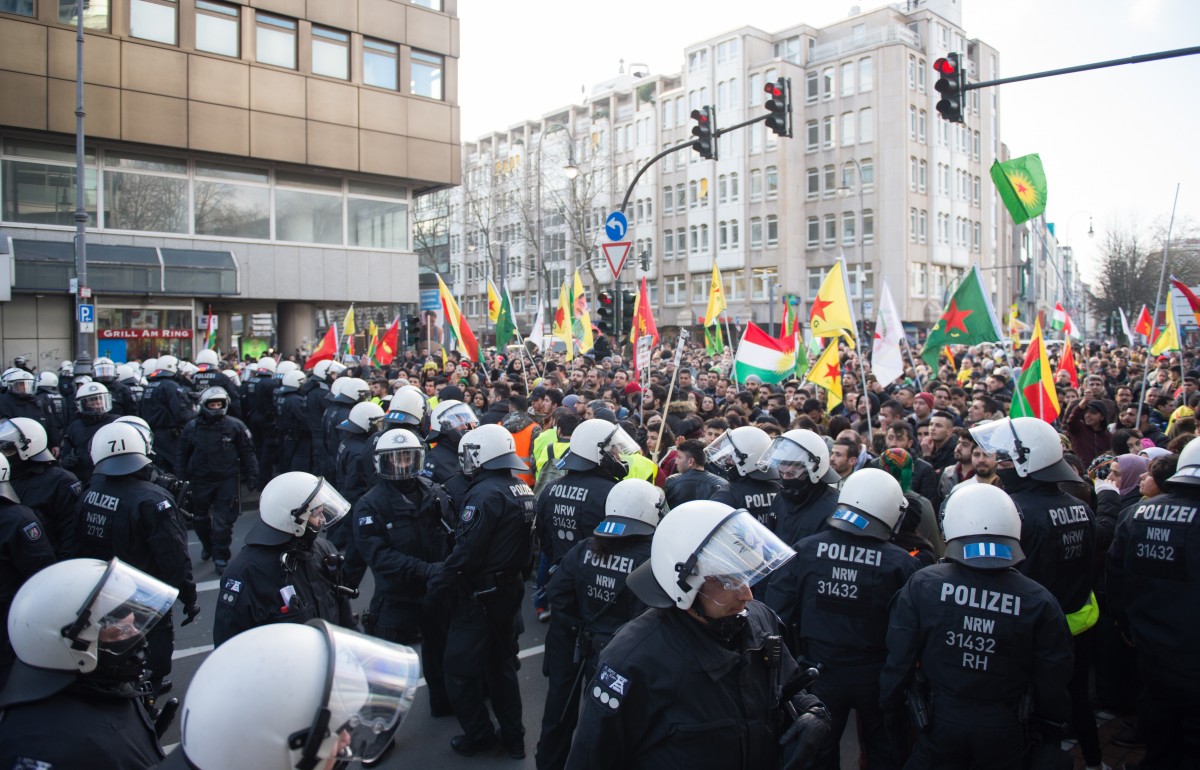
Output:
top-left (940, 482), bottom-right (1025, 570)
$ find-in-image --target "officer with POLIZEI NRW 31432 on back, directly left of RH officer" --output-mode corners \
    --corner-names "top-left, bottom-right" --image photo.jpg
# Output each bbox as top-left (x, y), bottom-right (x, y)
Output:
top-left (766, 468), bottom-right (920, 770)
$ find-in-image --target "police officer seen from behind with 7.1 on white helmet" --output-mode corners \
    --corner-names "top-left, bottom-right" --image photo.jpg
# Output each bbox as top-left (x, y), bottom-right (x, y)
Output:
top-left (73, 422), bottom-right (200, 694)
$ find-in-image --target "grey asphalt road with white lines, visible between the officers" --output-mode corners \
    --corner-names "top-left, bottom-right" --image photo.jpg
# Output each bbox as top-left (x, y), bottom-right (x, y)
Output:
top-left (163, 510), bottom-right (858, 770)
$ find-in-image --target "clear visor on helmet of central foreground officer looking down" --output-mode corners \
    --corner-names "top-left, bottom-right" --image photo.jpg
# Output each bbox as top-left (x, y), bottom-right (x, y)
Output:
top-left (694, 510), bottom-right (796, 590)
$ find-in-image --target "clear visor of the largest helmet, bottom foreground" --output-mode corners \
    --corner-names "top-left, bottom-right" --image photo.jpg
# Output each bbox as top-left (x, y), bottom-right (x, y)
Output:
top-left (313, 620), bottom-right (421, 762)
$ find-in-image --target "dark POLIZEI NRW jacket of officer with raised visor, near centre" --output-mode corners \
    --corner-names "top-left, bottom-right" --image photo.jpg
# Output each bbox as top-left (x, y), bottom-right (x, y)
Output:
top-left (538, 469), bottom-right (617, 564)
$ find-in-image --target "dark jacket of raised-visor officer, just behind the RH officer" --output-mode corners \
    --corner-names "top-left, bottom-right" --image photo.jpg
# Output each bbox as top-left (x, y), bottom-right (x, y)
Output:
top-left (1004, 475), bottom-right (1096, 614)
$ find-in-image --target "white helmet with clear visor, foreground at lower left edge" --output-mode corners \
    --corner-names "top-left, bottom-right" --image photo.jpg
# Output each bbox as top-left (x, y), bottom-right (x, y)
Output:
top-left (8, 559), bottom-right (179, 676)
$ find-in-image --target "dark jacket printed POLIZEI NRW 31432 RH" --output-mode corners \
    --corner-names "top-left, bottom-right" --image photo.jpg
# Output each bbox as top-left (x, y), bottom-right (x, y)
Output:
top-left (880, 563), bottom-right (1072, 722)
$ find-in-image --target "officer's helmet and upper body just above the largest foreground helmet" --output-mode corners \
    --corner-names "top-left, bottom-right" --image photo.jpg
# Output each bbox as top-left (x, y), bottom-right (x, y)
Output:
top-left (212, 471), bottom-right (356, 645)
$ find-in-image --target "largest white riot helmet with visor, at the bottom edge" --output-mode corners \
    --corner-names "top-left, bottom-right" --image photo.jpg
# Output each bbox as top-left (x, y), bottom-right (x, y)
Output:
top-left (168, 620), bottom-right (421, 770)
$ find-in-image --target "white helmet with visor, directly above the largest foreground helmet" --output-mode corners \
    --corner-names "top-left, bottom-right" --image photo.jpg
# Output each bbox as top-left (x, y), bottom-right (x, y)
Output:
top-left (246, 470), bottom-right (350, 546)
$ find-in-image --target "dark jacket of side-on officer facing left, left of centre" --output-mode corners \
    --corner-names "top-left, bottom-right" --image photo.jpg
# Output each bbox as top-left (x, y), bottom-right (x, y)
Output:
top-left (426, 460), bottom-right (534, 602)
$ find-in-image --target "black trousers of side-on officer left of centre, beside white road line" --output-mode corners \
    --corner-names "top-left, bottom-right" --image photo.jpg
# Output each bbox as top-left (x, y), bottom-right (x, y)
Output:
top-left (444, 580), bottom-right (524, 742)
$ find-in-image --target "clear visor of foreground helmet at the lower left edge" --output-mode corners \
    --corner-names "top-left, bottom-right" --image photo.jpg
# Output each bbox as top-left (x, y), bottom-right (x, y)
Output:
top-left (64, 559), bottom-right (179, 649)
